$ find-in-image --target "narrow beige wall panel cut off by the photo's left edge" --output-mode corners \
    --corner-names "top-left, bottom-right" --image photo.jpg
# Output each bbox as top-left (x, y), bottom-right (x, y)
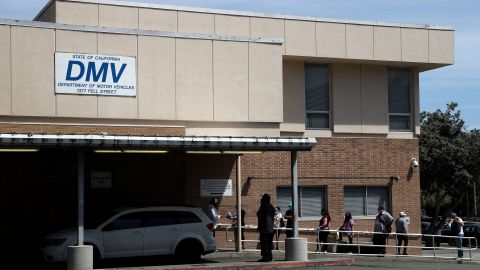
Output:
top-left (0, 25), bottom-right (12, 115)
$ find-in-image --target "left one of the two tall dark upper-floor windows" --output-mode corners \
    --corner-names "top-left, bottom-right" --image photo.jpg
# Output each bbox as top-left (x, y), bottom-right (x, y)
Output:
top-left (305, 64), bottom-right (330, 129)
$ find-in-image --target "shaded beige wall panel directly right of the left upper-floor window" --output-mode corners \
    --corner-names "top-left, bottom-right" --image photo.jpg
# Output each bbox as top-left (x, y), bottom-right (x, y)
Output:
top-left (332, 64), bottom-right (362, 133)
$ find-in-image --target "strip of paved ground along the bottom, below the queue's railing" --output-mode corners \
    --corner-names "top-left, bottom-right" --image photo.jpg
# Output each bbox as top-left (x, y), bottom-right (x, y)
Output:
top-left (101, 251), bottom-right (355, 270)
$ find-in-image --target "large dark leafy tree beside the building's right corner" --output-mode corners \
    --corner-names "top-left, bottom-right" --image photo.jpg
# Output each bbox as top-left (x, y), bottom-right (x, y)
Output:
top-left (420, 102), bottom-right (473, 232)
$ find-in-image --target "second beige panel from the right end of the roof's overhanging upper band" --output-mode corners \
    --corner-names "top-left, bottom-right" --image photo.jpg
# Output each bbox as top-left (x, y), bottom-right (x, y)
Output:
top-left (401, 28), bottom-right (428, 62)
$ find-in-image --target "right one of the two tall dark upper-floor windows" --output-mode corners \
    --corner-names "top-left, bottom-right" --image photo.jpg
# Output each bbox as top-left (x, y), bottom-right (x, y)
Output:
top-left (388, 68), bottom-right (412, 131)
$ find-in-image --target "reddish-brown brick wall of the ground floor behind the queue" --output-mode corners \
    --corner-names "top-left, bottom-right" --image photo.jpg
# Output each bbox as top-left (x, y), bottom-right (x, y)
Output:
top-left (186, 138), bottom-right (420, 253)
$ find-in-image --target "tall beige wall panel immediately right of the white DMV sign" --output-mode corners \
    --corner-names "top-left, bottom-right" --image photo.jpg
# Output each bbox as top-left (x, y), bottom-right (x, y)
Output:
top-left (137, 36), bottom-right (175, 120)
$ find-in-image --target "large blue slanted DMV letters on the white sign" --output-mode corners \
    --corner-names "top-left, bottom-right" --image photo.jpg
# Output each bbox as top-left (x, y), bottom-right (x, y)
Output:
top-left (65, 60), bottom-right (127, 83)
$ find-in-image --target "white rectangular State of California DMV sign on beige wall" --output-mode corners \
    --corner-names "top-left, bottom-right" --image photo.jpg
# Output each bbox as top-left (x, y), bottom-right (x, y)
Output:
top-left (55, 52), bottom-right (137, 96)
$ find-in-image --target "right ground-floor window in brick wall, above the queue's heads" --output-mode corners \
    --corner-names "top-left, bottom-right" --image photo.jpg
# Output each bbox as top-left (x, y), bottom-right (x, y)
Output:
top-left (344, 186), bottom-right (390, 216)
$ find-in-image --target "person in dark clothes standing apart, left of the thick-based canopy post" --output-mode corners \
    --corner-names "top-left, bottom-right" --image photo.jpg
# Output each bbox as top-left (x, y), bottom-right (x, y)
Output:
top-left (257, 194), bottom-right (275, 262)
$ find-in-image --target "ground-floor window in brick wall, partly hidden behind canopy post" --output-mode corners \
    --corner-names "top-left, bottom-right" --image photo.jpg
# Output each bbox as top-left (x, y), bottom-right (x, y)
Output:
top-left (277, 187), bottom-right (326, 217)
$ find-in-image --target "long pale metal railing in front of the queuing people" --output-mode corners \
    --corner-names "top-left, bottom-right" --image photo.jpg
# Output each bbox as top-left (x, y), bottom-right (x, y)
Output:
top-left (218, 224), bottom-right (480, 260)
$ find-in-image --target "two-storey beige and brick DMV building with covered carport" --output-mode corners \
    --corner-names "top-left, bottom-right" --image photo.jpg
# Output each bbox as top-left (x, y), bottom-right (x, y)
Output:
top-left (0, 0), bottom-right (454, 266)
